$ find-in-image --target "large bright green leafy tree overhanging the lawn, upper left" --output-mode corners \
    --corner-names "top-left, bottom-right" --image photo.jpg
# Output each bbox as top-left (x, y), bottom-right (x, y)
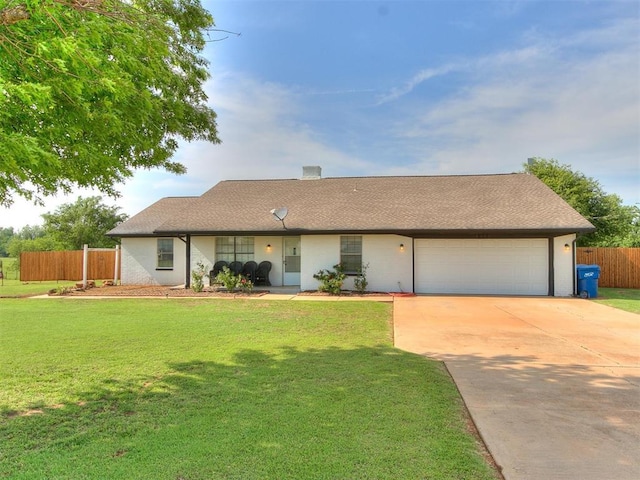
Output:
top-left (0, 0), bottom-right (219, 206)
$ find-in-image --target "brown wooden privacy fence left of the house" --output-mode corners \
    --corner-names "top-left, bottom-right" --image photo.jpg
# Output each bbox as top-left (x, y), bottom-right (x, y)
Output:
top-left (20, 249), bottom-right (120, 282)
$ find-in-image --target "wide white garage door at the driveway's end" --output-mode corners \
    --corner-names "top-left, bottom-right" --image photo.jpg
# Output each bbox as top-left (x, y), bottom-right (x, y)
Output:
top-left (415, 238), bottom-right (549, 295)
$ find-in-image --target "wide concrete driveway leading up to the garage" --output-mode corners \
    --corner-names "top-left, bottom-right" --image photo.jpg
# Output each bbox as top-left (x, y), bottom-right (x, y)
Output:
top-left (394, 297), bottom-right (640, 480)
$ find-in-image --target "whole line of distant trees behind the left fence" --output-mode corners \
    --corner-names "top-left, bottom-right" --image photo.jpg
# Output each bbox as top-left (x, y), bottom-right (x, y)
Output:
top-left (0, 197), bottom-right (128, 258)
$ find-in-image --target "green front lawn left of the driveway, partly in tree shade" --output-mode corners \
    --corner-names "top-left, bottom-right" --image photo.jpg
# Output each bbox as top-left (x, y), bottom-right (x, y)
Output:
top-left (0, 298), bottom-right (497, 480)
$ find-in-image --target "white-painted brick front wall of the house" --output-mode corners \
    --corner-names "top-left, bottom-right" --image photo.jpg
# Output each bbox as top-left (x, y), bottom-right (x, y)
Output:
top-left (122, 235), bottom-right (575, 296)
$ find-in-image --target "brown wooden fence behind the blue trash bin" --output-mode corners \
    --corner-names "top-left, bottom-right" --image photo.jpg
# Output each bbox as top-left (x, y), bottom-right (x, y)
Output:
top-left (576, 247), bottom-right (640, 288)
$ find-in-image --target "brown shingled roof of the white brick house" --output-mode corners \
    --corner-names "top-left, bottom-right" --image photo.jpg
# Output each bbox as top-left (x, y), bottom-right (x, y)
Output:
top-left (109, 173), bottom-right (594, 236)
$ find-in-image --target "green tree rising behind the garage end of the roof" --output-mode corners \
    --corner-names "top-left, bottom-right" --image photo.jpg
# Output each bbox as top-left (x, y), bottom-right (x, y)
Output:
top-left (524, 158), bottom-right (640, 247)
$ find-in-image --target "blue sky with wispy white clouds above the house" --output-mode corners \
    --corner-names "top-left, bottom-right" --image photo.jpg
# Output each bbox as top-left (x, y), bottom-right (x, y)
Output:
top-left (0, 0), bottom-right (640, 229)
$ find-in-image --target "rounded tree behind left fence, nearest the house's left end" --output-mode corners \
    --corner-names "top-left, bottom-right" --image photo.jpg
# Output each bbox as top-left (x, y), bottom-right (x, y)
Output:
top-left (42, 197), bottom-right (127, 250)
